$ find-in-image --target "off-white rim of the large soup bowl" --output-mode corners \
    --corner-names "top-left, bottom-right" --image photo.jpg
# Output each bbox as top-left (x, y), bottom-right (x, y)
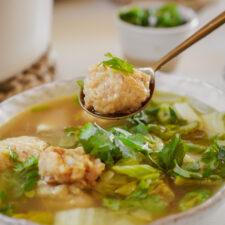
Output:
top-left (0, 75), bottom-right (225, 225)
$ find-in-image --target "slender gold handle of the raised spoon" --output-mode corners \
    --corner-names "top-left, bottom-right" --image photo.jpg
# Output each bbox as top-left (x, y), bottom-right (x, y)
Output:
top-left (152, 11), bottom-right (225, 72)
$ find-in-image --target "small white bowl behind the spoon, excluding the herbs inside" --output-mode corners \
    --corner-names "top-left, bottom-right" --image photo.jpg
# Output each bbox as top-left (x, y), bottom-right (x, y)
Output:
top-left (116, 2), bottom-right (199, 70)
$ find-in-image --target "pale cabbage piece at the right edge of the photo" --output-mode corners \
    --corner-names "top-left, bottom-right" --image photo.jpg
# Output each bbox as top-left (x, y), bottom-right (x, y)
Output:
top-left (202, 112), bottom-right (225, 135)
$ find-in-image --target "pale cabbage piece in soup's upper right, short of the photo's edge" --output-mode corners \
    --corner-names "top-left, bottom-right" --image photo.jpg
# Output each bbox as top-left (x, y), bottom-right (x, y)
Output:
top-left (174, 102), bottom-right (201, 123)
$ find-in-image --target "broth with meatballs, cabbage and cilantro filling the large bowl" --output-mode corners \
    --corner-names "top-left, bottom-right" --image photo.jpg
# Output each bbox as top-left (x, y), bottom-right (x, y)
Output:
top-left (0, 91), bottom-right (225, 225)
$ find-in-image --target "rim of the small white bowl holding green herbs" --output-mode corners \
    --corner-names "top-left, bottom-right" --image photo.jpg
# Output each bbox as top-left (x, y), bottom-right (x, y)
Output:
top-left (115, 1), bottom-right (199, 35)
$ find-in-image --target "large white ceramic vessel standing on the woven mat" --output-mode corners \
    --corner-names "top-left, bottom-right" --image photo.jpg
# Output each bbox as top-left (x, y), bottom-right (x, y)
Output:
top-left (0, 0), bottom-right (53, 82)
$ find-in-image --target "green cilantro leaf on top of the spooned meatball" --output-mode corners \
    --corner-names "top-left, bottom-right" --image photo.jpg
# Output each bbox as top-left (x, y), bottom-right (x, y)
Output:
top-left (102, 52), bottom-right (134, 74)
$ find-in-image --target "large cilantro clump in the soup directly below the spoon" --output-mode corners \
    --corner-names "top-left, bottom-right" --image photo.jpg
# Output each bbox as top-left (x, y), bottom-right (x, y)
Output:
top-left (80, 123), bottom-right (151, 165)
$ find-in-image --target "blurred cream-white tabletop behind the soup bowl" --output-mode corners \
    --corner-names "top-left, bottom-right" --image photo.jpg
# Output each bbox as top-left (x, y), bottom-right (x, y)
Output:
top-left (52, 0), bottom-right (225, 90)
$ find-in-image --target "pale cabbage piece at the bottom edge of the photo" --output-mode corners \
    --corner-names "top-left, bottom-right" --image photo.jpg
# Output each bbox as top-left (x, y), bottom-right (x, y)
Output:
top-left (54, 208), bottom-right (134, 225)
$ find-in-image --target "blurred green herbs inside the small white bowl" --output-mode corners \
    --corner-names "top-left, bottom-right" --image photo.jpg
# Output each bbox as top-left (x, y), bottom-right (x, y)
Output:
top-left (119, 3), bottom-right (187, 28)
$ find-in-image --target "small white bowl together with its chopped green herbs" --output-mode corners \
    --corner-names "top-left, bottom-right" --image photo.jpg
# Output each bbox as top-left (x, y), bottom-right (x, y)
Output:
top-left (115, 1), bottom-right (199, 72)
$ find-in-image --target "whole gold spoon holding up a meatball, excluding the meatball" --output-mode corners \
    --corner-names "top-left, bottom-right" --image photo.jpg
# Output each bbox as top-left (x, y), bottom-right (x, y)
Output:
top-left (79, 11), bottom-right (225, 120)
